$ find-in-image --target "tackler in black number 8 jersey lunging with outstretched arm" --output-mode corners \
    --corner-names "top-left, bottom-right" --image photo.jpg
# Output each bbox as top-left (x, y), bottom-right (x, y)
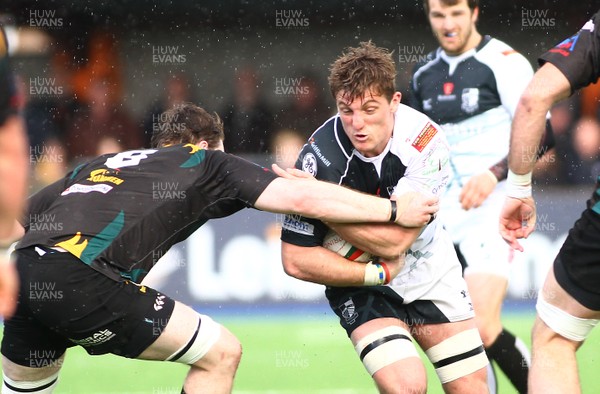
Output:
top-left (2, 105), bottom-right (437, 394)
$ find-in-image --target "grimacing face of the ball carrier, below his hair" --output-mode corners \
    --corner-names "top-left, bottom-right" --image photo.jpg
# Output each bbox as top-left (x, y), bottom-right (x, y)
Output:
top-left (336, 90), bottom-right (401, 157)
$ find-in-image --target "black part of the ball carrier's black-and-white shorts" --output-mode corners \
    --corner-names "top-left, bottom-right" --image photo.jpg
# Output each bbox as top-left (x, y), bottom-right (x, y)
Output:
top-left (325, 286), bottom-right (450, 336)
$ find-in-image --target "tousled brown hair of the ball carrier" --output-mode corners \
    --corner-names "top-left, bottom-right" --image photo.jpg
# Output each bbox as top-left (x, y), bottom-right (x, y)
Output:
top-left (328, 41), bottom-right (396, 102)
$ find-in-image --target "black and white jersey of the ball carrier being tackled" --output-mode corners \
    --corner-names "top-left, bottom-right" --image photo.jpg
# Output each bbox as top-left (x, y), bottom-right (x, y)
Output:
top-left (281, 104), bottom-right (449, 254)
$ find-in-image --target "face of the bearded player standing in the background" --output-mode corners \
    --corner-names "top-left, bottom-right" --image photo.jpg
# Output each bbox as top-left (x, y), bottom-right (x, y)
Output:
top-left (429, 0), bottom-right (479, 56)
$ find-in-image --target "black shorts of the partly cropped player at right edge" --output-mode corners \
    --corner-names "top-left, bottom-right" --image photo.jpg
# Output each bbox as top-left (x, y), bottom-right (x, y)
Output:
top-left (554, 188), bottom-right (600, 311)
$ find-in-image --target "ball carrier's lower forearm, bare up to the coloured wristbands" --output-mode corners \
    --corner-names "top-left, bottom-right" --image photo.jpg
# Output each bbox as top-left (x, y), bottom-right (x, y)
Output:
top-left (281, 242), bottom-right (365, 286)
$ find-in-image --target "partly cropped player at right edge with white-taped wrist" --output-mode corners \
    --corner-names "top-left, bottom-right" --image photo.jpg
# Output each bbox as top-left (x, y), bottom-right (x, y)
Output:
top-left (500, 12), bottom-right (600, 393)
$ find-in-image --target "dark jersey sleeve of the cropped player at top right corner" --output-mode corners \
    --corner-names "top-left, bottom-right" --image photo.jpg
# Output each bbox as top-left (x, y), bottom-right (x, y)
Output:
top-left (538, 12), bottom-right (600, 93)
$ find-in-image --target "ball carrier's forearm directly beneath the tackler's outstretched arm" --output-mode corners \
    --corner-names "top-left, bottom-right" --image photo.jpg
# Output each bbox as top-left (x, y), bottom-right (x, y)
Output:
top-left (327, 223), bottom-right (421, 261)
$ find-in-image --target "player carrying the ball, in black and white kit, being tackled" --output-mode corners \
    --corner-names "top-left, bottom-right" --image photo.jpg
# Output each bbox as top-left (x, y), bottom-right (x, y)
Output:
top-left (282, 42), bottom-right (488, 394)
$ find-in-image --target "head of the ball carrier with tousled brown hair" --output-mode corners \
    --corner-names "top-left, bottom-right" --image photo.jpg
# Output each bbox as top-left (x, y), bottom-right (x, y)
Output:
top-left (329, 41), bottom-right (401, 157)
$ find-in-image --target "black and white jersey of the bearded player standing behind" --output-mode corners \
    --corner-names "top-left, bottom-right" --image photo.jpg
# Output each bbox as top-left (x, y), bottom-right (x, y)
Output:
top-left (411, 36), bottom-right (535, 188)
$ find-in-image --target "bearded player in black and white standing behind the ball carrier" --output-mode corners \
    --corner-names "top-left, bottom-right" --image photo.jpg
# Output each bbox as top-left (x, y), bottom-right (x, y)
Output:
top-left (410, 0), bottom-right (549, 393)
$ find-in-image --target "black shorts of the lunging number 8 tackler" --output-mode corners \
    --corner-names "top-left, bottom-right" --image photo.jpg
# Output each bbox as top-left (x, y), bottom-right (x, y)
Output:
top-left (2, 247), bottom-right (175, 368)
